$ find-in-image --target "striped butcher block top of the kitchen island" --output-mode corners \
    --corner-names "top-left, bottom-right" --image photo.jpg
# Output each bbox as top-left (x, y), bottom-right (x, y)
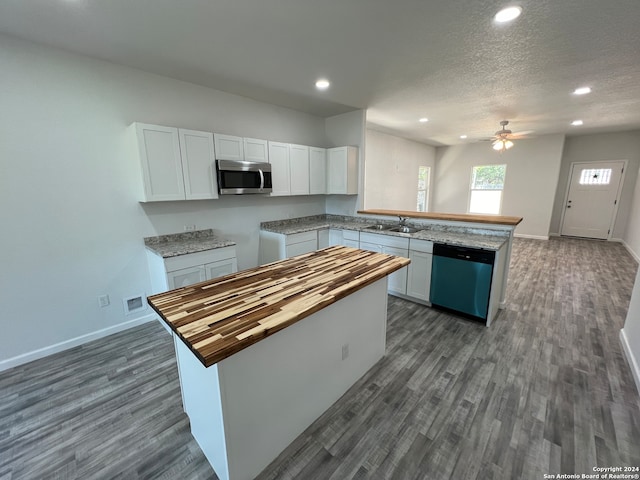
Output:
top-left (148, 246), bottom-right (410, 367)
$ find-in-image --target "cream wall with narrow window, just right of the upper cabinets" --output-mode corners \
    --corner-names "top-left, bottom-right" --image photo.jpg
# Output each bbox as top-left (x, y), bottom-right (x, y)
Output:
top-left (364, 129), bottom-right (436, 211)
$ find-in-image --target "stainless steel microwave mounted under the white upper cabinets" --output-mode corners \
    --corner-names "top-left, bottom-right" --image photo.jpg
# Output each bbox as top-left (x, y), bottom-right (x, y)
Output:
top-left (216, 160), bottom-right (272, 195)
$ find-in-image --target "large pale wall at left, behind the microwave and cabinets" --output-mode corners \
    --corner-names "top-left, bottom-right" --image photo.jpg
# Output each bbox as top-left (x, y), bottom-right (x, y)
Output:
top-left (0, 36), bottom-right (329, 369)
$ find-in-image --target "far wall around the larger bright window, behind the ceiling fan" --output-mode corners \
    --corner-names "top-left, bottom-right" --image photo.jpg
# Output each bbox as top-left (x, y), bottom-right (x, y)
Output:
top-left (432, 135), bottom-right (564, 238)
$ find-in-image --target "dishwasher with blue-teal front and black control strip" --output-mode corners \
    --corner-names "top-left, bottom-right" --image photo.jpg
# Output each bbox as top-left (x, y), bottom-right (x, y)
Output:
top-left (430, 243), bottom-right (495, 322)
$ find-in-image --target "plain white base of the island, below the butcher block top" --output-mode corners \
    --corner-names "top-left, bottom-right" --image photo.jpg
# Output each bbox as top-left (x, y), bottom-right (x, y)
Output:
top-left (176, 277), bottom-right (387, 480)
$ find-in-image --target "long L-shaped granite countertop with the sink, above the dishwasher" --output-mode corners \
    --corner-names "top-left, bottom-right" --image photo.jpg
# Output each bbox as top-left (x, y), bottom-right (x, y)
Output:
top-left (260, 215), bottom-right (509, 250)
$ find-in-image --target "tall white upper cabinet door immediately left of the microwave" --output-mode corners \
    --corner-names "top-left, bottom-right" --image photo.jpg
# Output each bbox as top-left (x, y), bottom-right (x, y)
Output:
top-left (178, 129), bottom-right (218, 200)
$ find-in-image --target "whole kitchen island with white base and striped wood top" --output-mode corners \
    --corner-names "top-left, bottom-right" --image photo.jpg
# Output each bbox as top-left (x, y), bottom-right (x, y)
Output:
top-left (148, 246), bottom-right (409, 480)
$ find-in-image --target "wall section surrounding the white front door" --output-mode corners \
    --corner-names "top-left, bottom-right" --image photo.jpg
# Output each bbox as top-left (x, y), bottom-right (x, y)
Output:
top-left (550, 130), bottom-right (640, 239)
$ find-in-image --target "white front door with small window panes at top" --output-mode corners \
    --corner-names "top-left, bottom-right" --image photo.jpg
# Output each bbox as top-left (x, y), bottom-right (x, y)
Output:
top-left (560, 161), bottom-right (625, 239)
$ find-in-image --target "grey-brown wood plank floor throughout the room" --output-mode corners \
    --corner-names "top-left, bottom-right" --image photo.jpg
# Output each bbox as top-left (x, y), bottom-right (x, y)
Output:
top-left (0, 238), bottom-right (640, 480)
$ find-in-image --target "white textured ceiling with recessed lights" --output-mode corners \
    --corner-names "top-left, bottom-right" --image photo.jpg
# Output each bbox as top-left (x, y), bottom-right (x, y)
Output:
top-left (0, 0), bottom-right (640, 145)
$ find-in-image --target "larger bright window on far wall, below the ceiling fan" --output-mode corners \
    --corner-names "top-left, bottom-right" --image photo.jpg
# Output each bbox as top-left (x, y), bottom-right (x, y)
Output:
top-left (469, 165), bottom-right (507, 214)
